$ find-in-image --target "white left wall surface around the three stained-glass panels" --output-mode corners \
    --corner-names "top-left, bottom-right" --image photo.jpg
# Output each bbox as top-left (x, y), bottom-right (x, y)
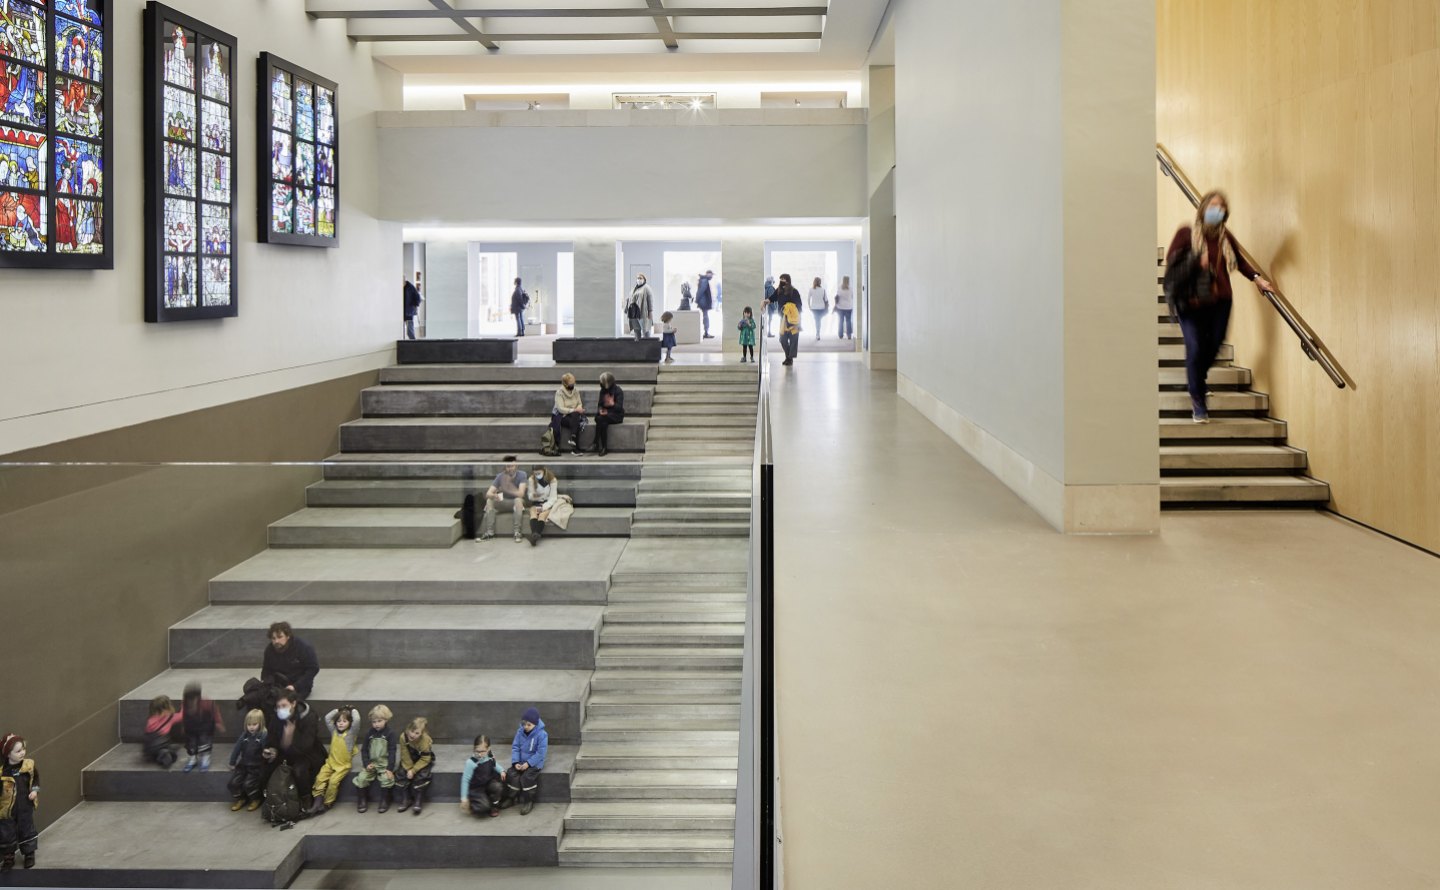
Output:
top-left (0, 0), bottom-right (402, 454)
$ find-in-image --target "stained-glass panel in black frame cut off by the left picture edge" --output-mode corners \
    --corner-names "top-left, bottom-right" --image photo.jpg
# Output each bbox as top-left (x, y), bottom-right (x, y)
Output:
top-left (0, 0), bottom-right (115, 269)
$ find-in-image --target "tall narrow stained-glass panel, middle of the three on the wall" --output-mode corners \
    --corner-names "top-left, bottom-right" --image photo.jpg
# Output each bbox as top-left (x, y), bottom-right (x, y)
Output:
top-left (145, 3), bottom-right (239, 321)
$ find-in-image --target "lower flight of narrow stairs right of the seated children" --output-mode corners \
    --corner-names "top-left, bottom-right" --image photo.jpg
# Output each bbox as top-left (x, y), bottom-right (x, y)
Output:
top-left (560, 558), bottom-right (749, 867)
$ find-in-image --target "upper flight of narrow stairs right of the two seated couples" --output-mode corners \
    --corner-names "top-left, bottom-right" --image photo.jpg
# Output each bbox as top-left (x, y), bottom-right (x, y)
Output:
top-left (631, 364), bottom-right (759, 539)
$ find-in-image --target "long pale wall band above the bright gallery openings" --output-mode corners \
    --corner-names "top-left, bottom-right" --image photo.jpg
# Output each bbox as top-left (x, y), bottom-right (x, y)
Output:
top-left (380, 109), bottom-right (868, 225)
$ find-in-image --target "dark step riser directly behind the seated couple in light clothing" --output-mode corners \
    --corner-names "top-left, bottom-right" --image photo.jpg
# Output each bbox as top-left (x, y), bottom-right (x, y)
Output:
top-left (305, 477), bottom-right (636, 510)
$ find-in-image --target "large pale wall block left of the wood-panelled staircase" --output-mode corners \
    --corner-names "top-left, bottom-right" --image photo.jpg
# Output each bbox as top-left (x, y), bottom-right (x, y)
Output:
top-left (894, 0), bottom-right (1159, 531)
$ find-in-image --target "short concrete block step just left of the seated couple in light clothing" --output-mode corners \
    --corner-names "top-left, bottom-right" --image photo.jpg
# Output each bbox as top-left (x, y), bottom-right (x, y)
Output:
top-left (269, 507), bottom-right (461, 549)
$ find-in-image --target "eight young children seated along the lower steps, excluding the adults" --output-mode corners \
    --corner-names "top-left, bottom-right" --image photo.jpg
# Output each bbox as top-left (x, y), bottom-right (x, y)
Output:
top-left (143, 683), bottom-right (550, 817)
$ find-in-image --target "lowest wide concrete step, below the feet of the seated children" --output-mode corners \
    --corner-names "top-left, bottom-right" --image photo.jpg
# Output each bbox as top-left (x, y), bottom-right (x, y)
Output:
top-left (28, 800), bottom-right (567, 889)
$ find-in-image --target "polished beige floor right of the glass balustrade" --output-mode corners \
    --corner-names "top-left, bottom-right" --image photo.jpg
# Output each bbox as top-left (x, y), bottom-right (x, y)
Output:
top-left (772, 353), bottom-right (1440, 890)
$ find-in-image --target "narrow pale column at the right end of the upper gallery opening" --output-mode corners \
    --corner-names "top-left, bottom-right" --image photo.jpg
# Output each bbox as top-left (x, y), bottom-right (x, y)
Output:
top-left (855, 65), bottom-right (896, 370)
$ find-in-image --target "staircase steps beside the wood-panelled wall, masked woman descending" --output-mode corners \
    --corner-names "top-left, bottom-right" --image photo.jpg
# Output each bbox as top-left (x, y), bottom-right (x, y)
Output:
top-left (1156, 256), bottom-right (1331, 508)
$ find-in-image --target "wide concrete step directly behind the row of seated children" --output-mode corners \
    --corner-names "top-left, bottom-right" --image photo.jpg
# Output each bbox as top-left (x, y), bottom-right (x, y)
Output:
top-left (120, 665), bottom-right (590, 745)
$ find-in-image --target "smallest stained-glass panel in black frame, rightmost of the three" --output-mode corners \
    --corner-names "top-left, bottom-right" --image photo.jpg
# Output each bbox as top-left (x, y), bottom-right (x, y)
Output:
top-left (256, 53), bottom-right (340, 248)
